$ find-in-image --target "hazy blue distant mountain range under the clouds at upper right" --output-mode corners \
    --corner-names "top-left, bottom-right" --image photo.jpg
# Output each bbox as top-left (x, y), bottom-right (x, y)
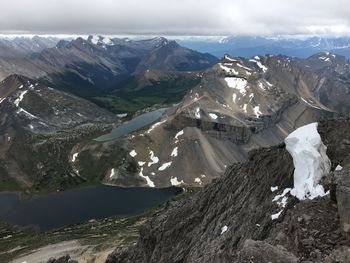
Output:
top-left (178, 36), bottom-right (350, 58)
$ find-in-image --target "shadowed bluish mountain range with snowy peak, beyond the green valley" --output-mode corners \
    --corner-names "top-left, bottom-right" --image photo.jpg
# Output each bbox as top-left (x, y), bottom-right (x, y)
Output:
top-left (0, 36), bottom-right (217, 97)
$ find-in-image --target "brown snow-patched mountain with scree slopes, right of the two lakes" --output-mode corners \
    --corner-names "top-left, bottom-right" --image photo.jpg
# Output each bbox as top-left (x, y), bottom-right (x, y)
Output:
top-left (91, 54), bottom-right (350, 190)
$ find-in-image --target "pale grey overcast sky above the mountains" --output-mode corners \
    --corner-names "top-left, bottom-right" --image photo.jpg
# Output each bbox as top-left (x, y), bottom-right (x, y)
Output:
top-left (0, 0), bottom-right (350, 35)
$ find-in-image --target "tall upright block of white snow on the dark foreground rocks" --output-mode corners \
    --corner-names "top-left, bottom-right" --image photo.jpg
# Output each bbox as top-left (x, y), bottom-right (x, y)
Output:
top-left (285, 123), bottom-right (331, 200)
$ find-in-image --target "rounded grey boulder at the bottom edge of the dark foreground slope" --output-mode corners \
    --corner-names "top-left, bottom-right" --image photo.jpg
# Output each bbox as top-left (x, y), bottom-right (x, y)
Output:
top-left (238, 239), bottom-right (298, 263)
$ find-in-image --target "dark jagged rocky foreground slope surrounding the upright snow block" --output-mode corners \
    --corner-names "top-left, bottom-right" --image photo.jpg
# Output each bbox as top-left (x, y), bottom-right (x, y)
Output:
top-left (107, 120), bottom-right (350, 263)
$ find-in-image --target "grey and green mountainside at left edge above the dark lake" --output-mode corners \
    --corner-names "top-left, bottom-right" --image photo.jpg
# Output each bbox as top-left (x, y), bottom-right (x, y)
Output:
top-left (0, 75), bottom-right (118, 192)
